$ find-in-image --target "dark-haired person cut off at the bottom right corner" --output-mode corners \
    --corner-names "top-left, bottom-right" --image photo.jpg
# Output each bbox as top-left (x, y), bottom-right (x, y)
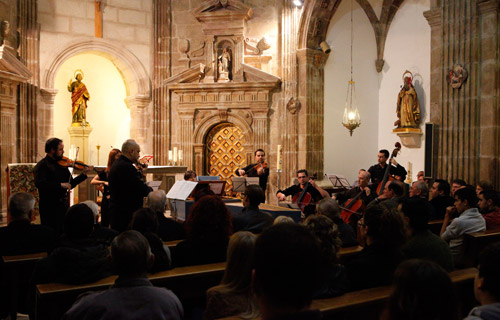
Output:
top-left (464, 242), bottom-right (500, 320)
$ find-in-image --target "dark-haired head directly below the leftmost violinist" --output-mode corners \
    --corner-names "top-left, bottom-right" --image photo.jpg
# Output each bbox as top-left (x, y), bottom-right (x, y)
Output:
top-left (64, 203), bottom-right (94, 239)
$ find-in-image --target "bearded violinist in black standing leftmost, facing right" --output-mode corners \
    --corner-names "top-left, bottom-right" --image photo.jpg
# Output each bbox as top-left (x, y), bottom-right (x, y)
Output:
top-left (33, 138), bottom-right (94, 234)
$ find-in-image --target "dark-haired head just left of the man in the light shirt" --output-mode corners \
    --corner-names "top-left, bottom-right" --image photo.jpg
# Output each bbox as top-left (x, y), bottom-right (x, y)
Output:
top-left (399, 198), bottom-right (431, 234)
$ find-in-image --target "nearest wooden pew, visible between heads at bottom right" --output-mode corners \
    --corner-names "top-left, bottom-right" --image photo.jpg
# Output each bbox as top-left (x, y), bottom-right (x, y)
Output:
top-left (224, 268), bottom-right (477, 320)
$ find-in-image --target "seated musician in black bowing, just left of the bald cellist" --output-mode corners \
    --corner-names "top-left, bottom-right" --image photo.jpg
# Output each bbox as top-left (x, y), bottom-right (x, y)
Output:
top-left (276, 169), bottom-right (330, 216)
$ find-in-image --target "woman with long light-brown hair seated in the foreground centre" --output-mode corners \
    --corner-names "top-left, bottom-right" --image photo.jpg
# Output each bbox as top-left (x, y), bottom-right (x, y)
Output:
top-left (205, 231), bottom-right (257, 319)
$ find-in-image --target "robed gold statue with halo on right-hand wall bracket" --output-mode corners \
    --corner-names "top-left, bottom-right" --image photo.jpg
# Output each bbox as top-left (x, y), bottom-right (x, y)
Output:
top-left (394, 70), bottom-right (420, 129)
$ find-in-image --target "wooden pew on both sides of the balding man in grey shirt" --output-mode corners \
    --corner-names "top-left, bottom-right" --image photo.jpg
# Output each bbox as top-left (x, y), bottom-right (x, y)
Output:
top-left (35, 262), bottom-right (226, 319)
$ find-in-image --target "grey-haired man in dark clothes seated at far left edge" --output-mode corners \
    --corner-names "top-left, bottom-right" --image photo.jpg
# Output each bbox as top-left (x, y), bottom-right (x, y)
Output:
top-left (0, 192), bottom-right (55, 256)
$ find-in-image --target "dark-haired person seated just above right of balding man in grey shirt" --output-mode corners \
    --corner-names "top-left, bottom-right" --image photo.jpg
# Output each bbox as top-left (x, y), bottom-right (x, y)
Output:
top-left (129, 208), bottom-right (172, 273)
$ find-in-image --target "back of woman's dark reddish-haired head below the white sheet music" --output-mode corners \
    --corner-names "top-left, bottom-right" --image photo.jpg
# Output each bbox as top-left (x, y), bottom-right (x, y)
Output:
top-left (185, 196), bottom-right (232, 241)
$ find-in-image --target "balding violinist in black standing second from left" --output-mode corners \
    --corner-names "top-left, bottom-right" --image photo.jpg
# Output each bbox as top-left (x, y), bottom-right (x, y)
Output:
top-left (108, 139), bottom-right (153, 232)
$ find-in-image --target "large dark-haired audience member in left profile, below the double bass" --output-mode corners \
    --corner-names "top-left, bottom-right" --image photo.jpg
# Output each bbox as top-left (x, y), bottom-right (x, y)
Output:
top-left (346, 205), bottom-right (406, 290)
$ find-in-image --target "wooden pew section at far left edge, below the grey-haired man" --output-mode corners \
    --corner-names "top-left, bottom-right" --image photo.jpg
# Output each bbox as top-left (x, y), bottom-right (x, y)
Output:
top-left (0, 252), bottom-right (47, 319)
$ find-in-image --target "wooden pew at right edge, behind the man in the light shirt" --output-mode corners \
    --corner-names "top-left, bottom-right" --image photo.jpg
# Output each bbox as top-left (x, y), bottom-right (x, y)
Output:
top-left (463, 229), bottom-right (500, 267)
